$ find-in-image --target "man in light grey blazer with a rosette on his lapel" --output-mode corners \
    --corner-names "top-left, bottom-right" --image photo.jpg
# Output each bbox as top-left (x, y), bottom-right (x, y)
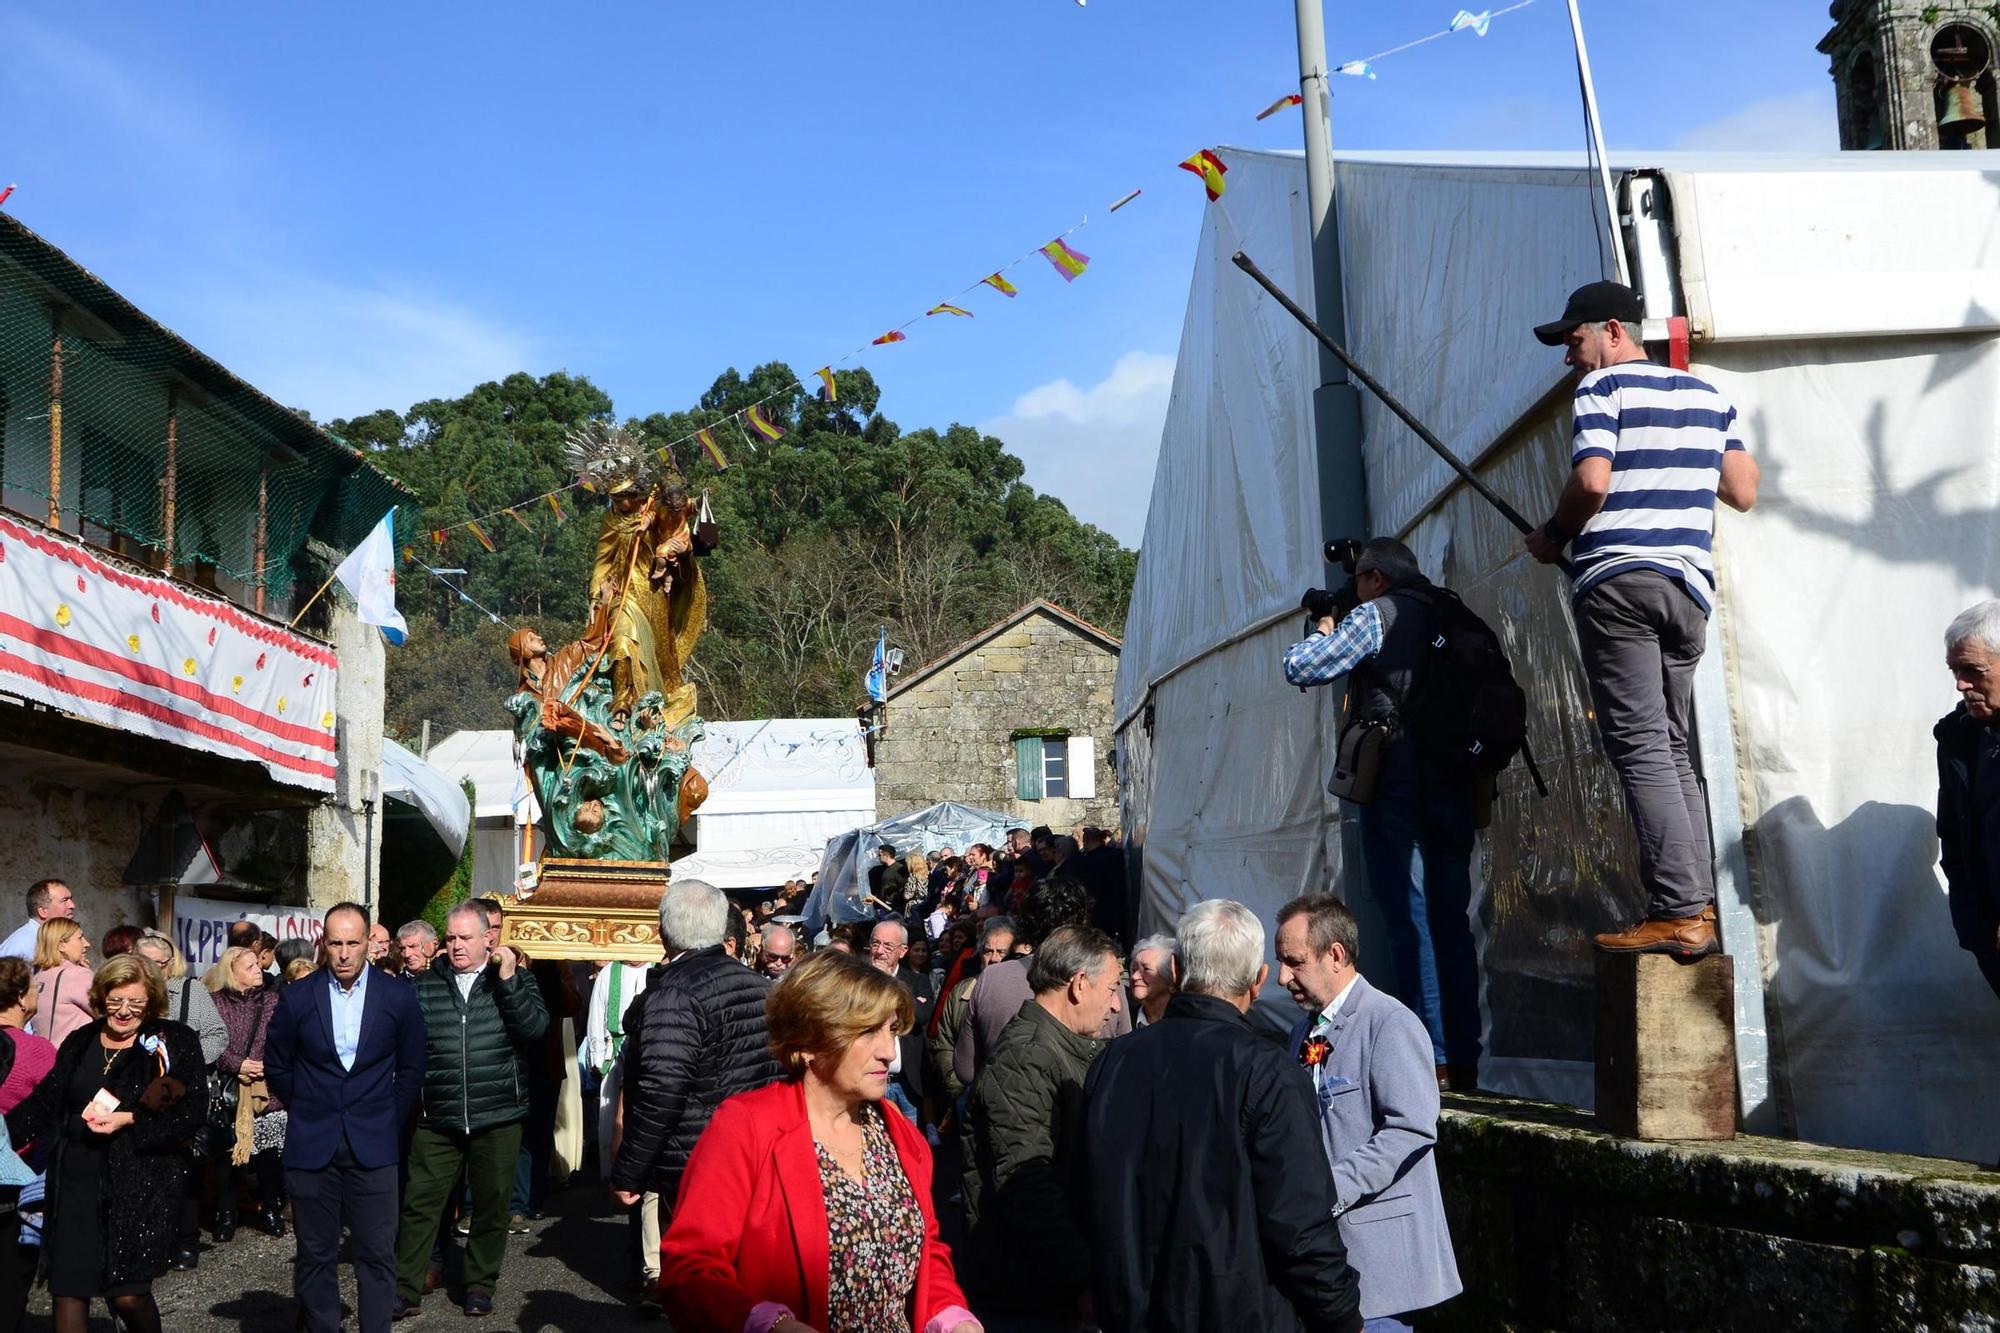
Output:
top-left (1276, 895), bottom-right (1462, 1333)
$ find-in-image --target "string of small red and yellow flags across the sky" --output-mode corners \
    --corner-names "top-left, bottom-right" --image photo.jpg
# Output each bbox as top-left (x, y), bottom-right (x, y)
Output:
top-left (410, 0), bottom-right (1534, 564)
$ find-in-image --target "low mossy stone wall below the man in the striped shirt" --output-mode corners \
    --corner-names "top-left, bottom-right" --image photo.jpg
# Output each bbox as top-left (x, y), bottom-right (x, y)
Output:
top-left (1424, 1089), bottom-right (2000, 1333)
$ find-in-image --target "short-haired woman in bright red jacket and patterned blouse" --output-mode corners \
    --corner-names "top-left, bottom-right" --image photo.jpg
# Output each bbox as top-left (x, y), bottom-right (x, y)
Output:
top-left (660, 951), bottom-right (980, 1333)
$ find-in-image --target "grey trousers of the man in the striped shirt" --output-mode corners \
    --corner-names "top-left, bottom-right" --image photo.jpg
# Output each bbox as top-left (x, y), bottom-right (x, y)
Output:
top-left (1576, 568), bottom-right (1716, 917)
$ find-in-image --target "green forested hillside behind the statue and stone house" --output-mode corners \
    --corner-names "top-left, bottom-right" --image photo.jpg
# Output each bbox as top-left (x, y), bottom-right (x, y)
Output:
top-left (328, 362), bottom-right (1142, 739)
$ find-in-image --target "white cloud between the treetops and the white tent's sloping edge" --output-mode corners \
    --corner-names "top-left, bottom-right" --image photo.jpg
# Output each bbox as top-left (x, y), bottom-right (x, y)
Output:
top-left (980, 352), bottom-right (1174, 546)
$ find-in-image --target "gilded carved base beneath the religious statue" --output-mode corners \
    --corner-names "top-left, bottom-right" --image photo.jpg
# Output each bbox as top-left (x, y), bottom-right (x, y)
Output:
top-left (500, 857), bottom-right (668, 965)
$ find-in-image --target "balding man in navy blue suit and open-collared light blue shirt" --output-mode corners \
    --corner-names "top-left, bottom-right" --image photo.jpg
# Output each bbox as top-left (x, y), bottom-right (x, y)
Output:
top-left (264, 903), bottom-right (424, 1333)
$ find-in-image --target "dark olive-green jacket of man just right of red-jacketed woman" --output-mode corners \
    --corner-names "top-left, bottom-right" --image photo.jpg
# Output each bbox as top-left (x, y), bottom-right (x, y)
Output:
top-left (962, 999), bottom-right (1106, 1317)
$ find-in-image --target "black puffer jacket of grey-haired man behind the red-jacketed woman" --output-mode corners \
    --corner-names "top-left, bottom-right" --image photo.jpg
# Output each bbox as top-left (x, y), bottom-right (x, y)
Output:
top-left (610, 945), bottom-right (784, 1207)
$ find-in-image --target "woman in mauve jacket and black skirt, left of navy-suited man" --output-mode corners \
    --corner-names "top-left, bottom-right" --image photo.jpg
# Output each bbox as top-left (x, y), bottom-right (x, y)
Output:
top-left (214, 949), bottom-right (286, 1245)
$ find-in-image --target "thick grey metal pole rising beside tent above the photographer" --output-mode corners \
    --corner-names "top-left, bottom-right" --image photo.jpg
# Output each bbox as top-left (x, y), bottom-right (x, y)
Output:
top-left (1294, 0), bottom-right (1368, 538)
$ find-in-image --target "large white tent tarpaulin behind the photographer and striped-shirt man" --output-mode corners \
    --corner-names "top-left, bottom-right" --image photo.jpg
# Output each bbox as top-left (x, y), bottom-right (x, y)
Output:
top-left (1116, 150), bottom-right (2000, 1159)
